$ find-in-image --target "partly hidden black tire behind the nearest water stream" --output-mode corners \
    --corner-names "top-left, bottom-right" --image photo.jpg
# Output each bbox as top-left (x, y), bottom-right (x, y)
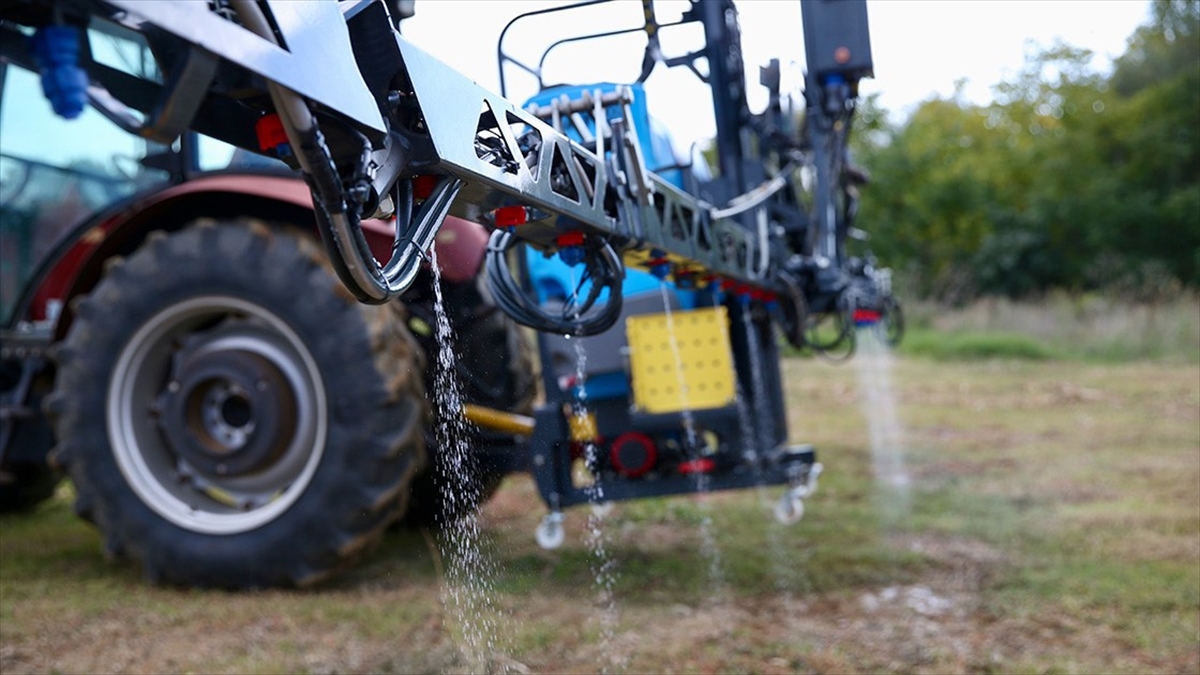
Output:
top-left (402, 274), bottom-right (536, 527)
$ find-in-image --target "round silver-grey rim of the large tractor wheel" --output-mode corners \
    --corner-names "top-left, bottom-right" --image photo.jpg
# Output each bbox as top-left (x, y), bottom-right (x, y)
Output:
top-left (107, 295), bottom-right (328, 534)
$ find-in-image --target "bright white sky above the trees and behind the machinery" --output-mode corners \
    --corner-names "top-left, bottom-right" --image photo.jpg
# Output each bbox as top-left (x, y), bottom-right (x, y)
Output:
top-left (403, 0), bottom-right (1148, 143)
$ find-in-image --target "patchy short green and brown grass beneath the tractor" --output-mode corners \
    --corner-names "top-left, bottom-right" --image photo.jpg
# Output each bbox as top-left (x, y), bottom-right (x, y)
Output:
top-left (0, 355), bottom-right (1200, 674)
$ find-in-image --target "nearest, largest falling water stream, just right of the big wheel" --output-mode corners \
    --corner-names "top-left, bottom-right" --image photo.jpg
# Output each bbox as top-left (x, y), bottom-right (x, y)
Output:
top-left (430, 249), bottom-right (505, 673)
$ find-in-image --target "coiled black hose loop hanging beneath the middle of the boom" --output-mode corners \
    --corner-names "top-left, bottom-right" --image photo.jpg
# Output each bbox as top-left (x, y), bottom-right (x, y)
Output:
top-left (487, 229), bottom-right (625, 336)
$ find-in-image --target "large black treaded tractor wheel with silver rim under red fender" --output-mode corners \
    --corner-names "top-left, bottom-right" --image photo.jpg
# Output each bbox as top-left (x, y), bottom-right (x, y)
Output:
top-left (47, 221), bottom-right (427, 589)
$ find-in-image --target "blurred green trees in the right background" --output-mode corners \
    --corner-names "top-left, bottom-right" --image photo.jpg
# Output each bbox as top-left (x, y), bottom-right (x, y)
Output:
top-left (854, 0), bottom-right (1200, 303)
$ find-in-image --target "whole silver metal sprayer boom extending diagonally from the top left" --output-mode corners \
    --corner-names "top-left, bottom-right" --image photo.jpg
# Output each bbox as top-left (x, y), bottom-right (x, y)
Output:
top-left (2, 0), bottom-right (844, 324)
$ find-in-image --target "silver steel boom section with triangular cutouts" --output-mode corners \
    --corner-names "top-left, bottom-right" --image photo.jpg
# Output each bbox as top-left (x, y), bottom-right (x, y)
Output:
top-left (388, 37), bottom-right (774, 288)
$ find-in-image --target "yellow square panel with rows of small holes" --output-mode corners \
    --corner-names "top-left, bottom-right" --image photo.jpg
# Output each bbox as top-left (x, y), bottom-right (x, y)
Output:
top-left (625, 307), bottom-right (737, 413)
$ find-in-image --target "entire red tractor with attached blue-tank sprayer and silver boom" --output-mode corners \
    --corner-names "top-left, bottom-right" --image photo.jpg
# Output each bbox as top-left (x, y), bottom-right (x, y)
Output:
top-left (0, 0), bottom-right (902, 587)
